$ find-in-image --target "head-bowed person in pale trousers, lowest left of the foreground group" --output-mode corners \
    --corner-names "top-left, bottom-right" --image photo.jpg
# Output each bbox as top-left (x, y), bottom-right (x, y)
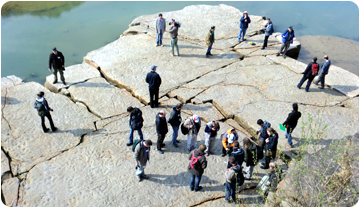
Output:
top-left (134, 140), bottom-right (152, 182)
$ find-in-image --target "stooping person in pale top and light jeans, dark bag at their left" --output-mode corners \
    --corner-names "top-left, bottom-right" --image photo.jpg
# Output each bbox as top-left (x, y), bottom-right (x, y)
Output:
top-left (184, 115), bottom-right (201, 151)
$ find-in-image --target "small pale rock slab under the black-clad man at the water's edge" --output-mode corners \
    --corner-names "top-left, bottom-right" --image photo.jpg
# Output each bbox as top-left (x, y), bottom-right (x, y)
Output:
top-left (44, 63), bottom-right (100, 96)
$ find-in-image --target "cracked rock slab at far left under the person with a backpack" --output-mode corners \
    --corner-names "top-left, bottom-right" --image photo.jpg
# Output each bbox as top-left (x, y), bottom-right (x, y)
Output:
top-left (1, 82), bottom-right (97, 175)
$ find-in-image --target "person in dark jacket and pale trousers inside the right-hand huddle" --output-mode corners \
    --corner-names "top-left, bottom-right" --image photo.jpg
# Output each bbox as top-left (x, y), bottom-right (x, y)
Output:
top-left (243, 137), bottom-right (257, 180)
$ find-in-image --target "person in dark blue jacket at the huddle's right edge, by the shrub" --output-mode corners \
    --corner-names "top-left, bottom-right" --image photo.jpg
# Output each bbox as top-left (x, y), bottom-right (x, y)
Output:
top-left (260, 127), bottom-right (279, 169)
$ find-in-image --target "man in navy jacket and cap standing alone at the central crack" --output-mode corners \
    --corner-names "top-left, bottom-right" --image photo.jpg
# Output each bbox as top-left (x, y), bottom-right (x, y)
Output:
top-left (145, 65), bottom-right (161, 108)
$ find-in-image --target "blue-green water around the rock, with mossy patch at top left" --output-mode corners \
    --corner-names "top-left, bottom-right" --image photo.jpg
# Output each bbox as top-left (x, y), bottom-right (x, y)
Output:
top-left (1, 1), bottom-right (359, 84)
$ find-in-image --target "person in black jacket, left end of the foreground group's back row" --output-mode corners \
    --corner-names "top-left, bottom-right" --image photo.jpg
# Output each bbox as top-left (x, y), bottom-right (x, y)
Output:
top-left (126, 106), bottom-right (144, 146)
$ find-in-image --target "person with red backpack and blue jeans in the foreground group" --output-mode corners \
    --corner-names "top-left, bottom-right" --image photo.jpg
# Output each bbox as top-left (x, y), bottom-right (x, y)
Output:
top-left (188, 144), bottom-right (207, 191)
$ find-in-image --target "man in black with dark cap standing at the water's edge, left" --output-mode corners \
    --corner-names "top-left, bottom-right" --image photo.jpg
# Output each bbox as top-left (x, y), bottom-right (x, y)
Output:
top-left (49, 48), bottom-right (66, 85)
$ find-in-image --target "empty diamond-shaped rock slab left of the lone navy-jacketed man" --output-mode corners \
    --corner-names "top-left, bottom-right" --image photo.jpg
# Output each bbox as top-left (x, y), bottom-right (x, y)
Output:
top-left (68, 77), bottom-right (143, 119)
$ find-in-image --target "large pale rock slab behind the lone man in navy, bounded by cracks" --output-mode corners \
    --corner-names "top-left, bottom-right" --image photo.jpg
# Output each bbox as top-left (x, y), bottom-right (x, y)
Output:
top-left (84, 34), bottom-right (239, 104)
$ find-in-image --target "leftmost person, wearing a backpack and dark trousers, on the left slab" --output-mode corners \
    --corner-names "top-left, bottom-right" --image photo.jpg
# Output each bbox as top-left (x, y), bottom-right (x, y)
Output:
top-left (34, 92), bottom-right (57, 133)
